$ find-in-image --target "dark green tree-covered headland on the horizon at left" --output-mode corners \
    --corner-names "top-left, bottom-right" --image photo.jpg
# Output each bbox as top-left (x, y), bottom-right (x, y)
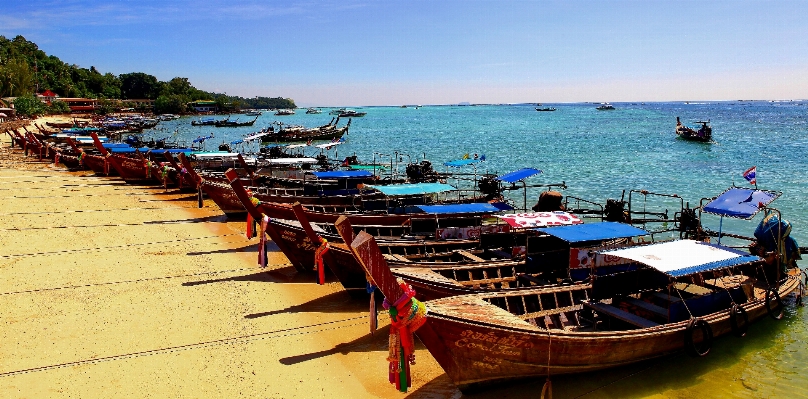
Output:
top-left (0, 35), bottom-right (297, 116)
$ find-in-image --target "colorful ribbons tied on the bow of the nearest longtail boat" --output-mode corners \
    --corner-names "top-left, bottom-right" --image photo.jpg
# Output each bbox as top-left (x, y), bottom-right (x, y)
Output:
top-left (382, 278), bottom-right (427, 392)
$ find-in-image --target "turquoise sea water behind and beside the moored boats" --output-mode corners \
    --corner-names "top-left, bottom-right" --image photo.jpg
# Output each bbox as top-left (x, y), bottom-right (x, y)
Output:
top-left (146, 101), bottom-right (808, 398)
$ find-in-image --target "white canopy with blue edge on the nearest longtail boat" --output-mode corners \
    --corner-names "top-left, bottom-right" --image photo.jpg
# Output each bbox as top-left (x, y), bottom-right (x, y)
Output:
top-left (598, 240), bottom-right (760, 277)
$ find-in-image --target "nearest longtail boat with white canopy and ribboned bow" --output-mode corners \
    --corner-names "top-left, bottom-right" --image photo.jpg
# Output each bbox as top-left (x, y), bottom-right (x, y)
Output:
top-left (351, 190), bottom-right (804, 393)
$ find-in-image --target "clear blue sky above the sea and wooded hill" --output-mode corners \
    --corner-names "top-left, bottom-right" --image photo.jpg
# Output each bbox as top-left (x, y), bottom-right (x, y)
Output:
top-left (0, 0), bottom-right (808, 106)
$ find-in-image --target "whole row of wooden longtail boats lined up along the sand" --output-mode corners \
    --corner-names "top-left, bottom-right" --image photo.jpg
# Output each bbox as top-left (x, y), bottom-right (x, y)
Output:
top-left (3, 124), bottom-right (805, 392)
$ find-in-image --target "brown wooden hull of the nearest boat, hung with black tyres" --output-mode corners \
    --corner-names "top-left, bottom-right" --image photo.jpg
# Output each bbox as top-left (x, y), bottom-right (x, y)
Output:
top-left (416, 278), bottom-right (799, 390)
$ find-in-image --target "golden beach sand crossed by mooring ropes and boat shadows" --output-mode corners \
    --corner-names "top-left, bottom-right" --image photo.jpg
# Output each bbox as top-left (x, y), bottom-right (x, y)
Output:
top-left (0, 130), bottom-right (468, 398)
